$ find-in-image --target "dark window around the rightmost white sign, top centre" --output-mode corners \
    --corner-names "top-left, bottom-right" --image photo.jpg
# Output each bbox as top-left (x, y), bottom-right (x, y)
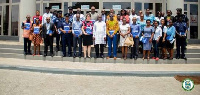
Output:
top-left (103, 2), bottom-right (131, 9)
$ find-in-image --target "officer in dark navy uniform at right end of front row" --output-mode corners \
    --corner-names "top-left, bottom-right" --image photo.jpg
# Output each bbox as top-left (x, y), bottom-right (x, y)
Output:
top-left (175, 17), bottom-right (187, 59)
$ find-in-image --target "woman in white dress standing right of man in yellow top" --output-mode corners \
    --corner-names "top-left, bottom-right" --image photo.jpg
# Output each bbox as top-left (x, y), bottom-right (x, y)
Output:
top-left (119, 18), bottom-right (130, 60)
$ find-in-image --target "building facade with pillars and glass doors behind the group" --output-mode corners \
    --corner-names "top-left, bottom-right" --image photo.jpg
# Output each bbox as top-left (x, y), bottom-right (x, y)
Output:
top-left (0, 0), bottom-right (200, 41)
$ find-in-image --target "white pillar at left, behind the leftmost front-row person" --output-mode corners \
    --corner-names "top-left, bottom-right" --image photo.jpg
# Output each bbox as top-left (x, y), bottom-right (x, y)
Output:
top-left (18, 0), bottom-right (36, 42)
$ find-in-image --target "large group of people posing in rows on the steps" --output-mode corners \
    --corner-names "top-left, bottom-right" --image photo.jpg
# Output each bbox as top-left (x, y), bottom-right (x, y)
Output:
top-left (22, 6), bottom-right (188, 60)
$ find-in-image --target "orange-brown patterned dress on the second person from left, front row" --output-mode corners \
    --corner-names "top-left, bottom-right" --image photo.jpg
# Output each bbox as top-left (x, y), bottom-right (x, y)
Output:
top-left (32, 24), bottom-right (42, 45)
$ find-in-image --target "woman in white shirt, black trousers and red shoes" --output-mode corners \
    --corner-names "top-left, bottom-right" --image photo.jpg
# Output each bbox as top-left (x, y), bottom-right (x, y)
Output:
top-left (152, 21), bottom-right (162, 61)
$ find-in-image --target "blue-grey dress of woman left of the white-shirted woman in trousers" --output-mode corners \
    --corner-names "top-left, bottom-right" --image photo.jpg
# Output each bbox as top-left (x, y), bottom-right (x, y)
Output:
top-left (143, 26), bottom-right (154, 50)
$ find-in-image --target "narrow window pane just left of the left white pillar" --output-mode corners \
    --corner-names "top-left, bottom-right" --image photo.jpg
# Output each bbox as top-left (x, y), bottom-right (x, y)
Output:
top-left (11, 5), bottom-right (19, 36)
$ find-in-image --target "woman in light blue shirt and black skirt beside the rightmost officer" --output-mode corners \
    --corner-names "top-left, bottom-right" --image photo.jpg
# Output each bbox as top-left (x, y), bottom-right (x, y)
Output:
top-left (166, 20), bottom-right (176, 60)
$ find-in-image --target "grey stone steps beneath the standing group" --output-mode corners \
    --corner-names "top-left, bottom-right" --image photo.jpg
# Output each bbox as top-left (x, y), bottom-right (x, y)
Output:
top-left (0, 41), bottom-right (200, 64)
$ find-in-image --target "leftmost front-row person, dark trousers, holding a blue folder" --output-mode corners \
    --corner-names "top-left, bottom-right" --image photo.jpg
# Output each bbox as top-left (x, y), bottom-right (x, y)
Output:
top-left (21, 15), bottom-right (33, 55)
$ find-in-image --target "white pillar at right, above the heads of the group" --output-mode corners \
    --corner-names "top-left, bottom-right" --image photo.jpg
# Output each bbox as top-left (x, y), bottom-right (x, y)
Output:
top-left (167, 0), bottom-right (184, 16)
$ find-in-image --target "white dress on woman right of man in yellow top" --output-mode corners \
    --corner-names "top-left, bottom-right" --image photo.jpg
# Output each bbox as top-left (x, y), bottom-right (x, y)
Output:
top-left (119, 24), bottom-right (130, 46)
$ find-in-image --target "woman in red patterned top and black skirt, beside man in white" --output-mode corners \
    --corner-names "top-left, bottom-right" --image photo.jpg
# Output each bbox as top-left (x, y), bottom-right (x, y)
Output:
top-left (82, 14), bottom-right (93, 58)
